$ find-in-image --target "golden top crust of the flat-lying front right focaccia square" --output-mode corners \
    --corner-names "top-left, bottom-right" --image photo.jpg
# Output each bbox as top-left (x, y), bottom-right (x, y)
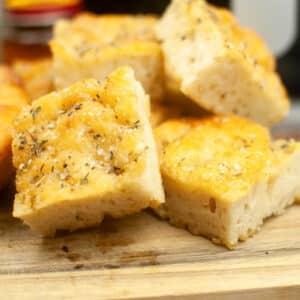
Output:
top-left (155, 116), bottom-right (282, 202)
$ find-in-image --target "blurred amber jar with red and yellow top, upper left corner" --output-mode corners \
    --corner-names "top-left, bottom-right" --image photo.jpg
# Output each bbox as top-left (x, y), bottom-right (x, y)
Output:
top-left (3, 0), bottom-right (82, 63)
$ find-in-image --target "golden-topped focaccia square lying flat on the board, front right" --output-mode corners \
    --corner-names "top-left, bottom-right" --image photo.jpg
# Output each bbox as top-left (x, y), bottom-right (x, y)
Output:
top-left (155, 116), bottom-right (300, 248)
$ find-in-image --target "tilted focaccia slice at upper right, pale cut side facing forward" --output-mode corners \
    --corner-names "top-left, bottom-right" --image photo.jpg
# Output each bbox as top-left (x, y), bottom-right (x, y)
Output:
top-left (156, 0), bottom-right (289, 126)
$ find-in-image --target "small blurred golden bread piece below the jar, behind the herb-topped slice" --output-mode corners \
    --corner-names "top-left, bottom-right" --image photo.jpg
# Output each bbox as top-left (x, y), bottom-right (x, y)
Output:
top-left (13, 58), bottom-right (54, 100)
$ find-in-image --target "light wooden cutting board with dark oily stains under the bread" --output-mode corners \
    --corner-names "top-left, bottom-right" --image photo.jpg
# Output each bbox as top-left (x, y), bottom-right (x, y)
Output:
top-left (0, 189), bottom-right (300, 300)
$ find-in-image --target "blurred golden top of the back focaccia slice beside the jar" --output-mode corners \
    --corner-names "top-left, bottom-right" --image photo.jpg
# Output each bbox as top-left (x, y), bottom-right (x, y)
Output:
top-left (51, 13), bottom-right (156, 56)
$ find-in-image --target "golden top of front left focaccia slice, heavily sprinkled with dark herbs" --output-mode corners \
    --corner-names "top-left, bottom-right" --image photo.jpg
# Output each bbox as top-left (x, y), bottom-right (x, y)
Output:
top-left (13, 67), bottom-right (154, 215)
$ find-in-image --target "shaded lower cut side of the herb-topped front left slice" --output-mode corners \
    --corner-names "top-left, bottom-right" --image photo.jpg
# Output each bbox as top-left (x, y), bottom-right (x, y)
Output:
top-left (22, 187), bottom-right (158, 237)
